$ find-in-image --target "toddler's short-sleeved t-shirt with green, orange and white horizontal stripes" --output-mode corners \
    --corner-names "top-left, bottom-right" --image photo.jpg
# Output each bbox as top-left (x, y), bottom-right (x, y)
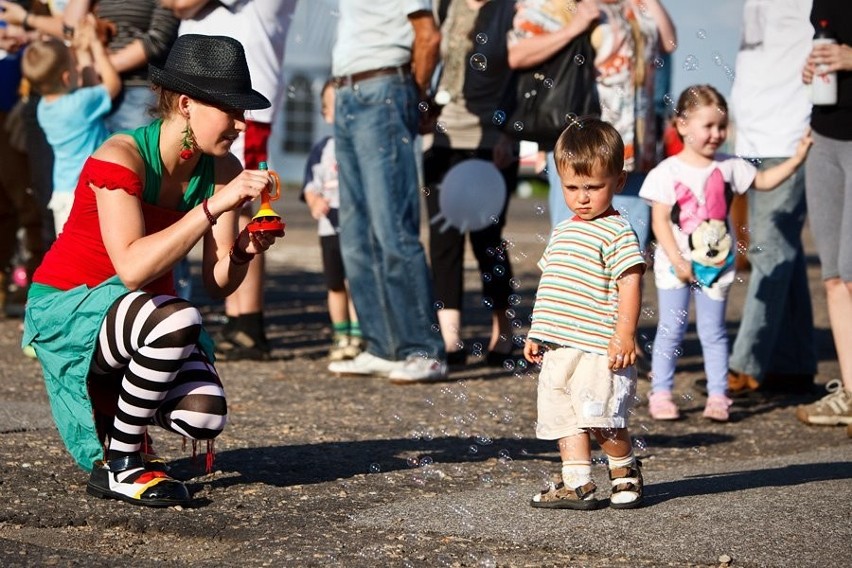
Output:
top-left (528, 212), bottom-right (645, 354)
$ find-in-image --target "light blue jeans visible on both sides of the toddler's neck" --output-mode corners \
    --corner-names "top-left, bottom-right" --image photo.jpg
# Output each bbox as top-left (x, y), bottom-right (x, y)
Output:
top-left (547, 152), bottom-right (651, 252)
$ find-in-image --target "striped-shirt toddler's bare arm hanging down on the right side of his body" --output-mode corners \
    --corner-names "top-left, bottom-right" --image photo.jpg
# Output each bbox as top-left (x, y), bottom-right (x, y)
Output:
top-left (607, 264), bottom-right (643, 371)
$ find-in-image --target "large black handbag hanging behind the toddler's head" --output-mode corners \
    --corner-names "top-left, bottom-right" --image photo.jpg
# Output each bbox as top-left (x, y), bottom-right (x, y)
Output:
top-left (503, 33), bottom-right (601, 151)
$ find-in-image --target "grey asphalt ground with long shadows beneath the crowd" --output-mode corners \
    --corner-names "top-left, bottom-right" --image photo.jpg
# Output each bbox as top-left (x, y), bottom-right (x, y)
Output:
top-left (0, 185), bottom-right (852, 568)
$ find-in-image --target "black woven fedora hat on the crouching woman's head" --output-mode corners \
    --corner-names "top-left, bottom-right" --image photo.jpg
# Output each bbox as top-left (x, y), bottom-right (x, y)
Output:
top-left (148, 34), bottom-right (271, 110)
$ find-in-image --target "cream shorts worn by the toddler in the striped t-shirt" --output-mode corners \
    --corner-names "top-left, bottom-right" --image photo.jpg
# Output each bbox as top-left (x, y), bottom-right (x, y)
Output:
top-left (535, 347), bottom-right (636, 440)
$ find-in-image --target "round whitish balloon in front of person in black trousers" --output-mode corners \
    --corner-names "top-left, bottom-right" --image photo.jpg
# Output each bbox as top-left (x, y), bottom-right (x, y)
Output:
top-left (431, 159), bottom-right (506, 233)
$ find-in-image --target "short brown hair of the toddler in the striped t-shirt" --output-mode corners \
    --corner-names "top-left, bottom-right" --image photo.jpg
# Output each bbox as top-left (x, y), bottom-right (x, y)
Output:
top-left (553, 117), bottom-right (624, 176)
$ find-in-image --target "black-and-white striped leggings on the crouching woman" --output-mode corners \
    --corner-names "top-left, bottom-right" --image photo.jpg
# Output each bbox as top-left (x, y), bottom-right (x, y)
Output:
top-left (89, 292), bottom-right (227, 454)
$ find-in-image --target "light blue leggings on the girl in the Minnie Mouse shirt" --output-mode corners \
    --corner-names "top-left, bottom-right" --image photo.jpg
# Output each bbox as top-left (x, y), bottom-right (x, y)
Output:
top-left (651, 286), bottom-right (728, 395)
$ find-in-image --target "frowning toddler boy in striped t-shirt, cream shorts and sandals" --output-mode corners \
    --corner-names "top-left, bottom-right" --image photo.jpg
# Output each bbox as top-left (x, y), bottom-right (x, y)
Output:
top-left (524, 118), bottom-right (645, 509)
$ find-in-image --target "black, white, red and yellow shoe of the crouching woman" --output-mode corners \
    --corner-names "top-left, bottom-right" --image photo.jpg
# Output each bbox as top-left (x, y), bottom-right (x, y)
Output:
top-left (86, 454), bottom-right (192, 507)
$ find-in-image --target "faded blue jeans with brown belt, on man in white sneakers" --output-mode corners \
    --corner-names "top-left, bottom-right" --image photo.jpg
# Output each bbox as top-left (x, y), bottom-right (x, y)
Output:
top-left (334, 75), bottom-right (444, 360)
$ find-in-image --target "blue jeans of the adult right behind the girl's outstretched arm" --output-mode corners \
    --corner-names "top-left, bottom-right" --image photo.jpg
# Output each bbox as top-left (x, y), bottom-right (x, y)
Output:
top-left (730, 158), bottom-right (817, 381)
